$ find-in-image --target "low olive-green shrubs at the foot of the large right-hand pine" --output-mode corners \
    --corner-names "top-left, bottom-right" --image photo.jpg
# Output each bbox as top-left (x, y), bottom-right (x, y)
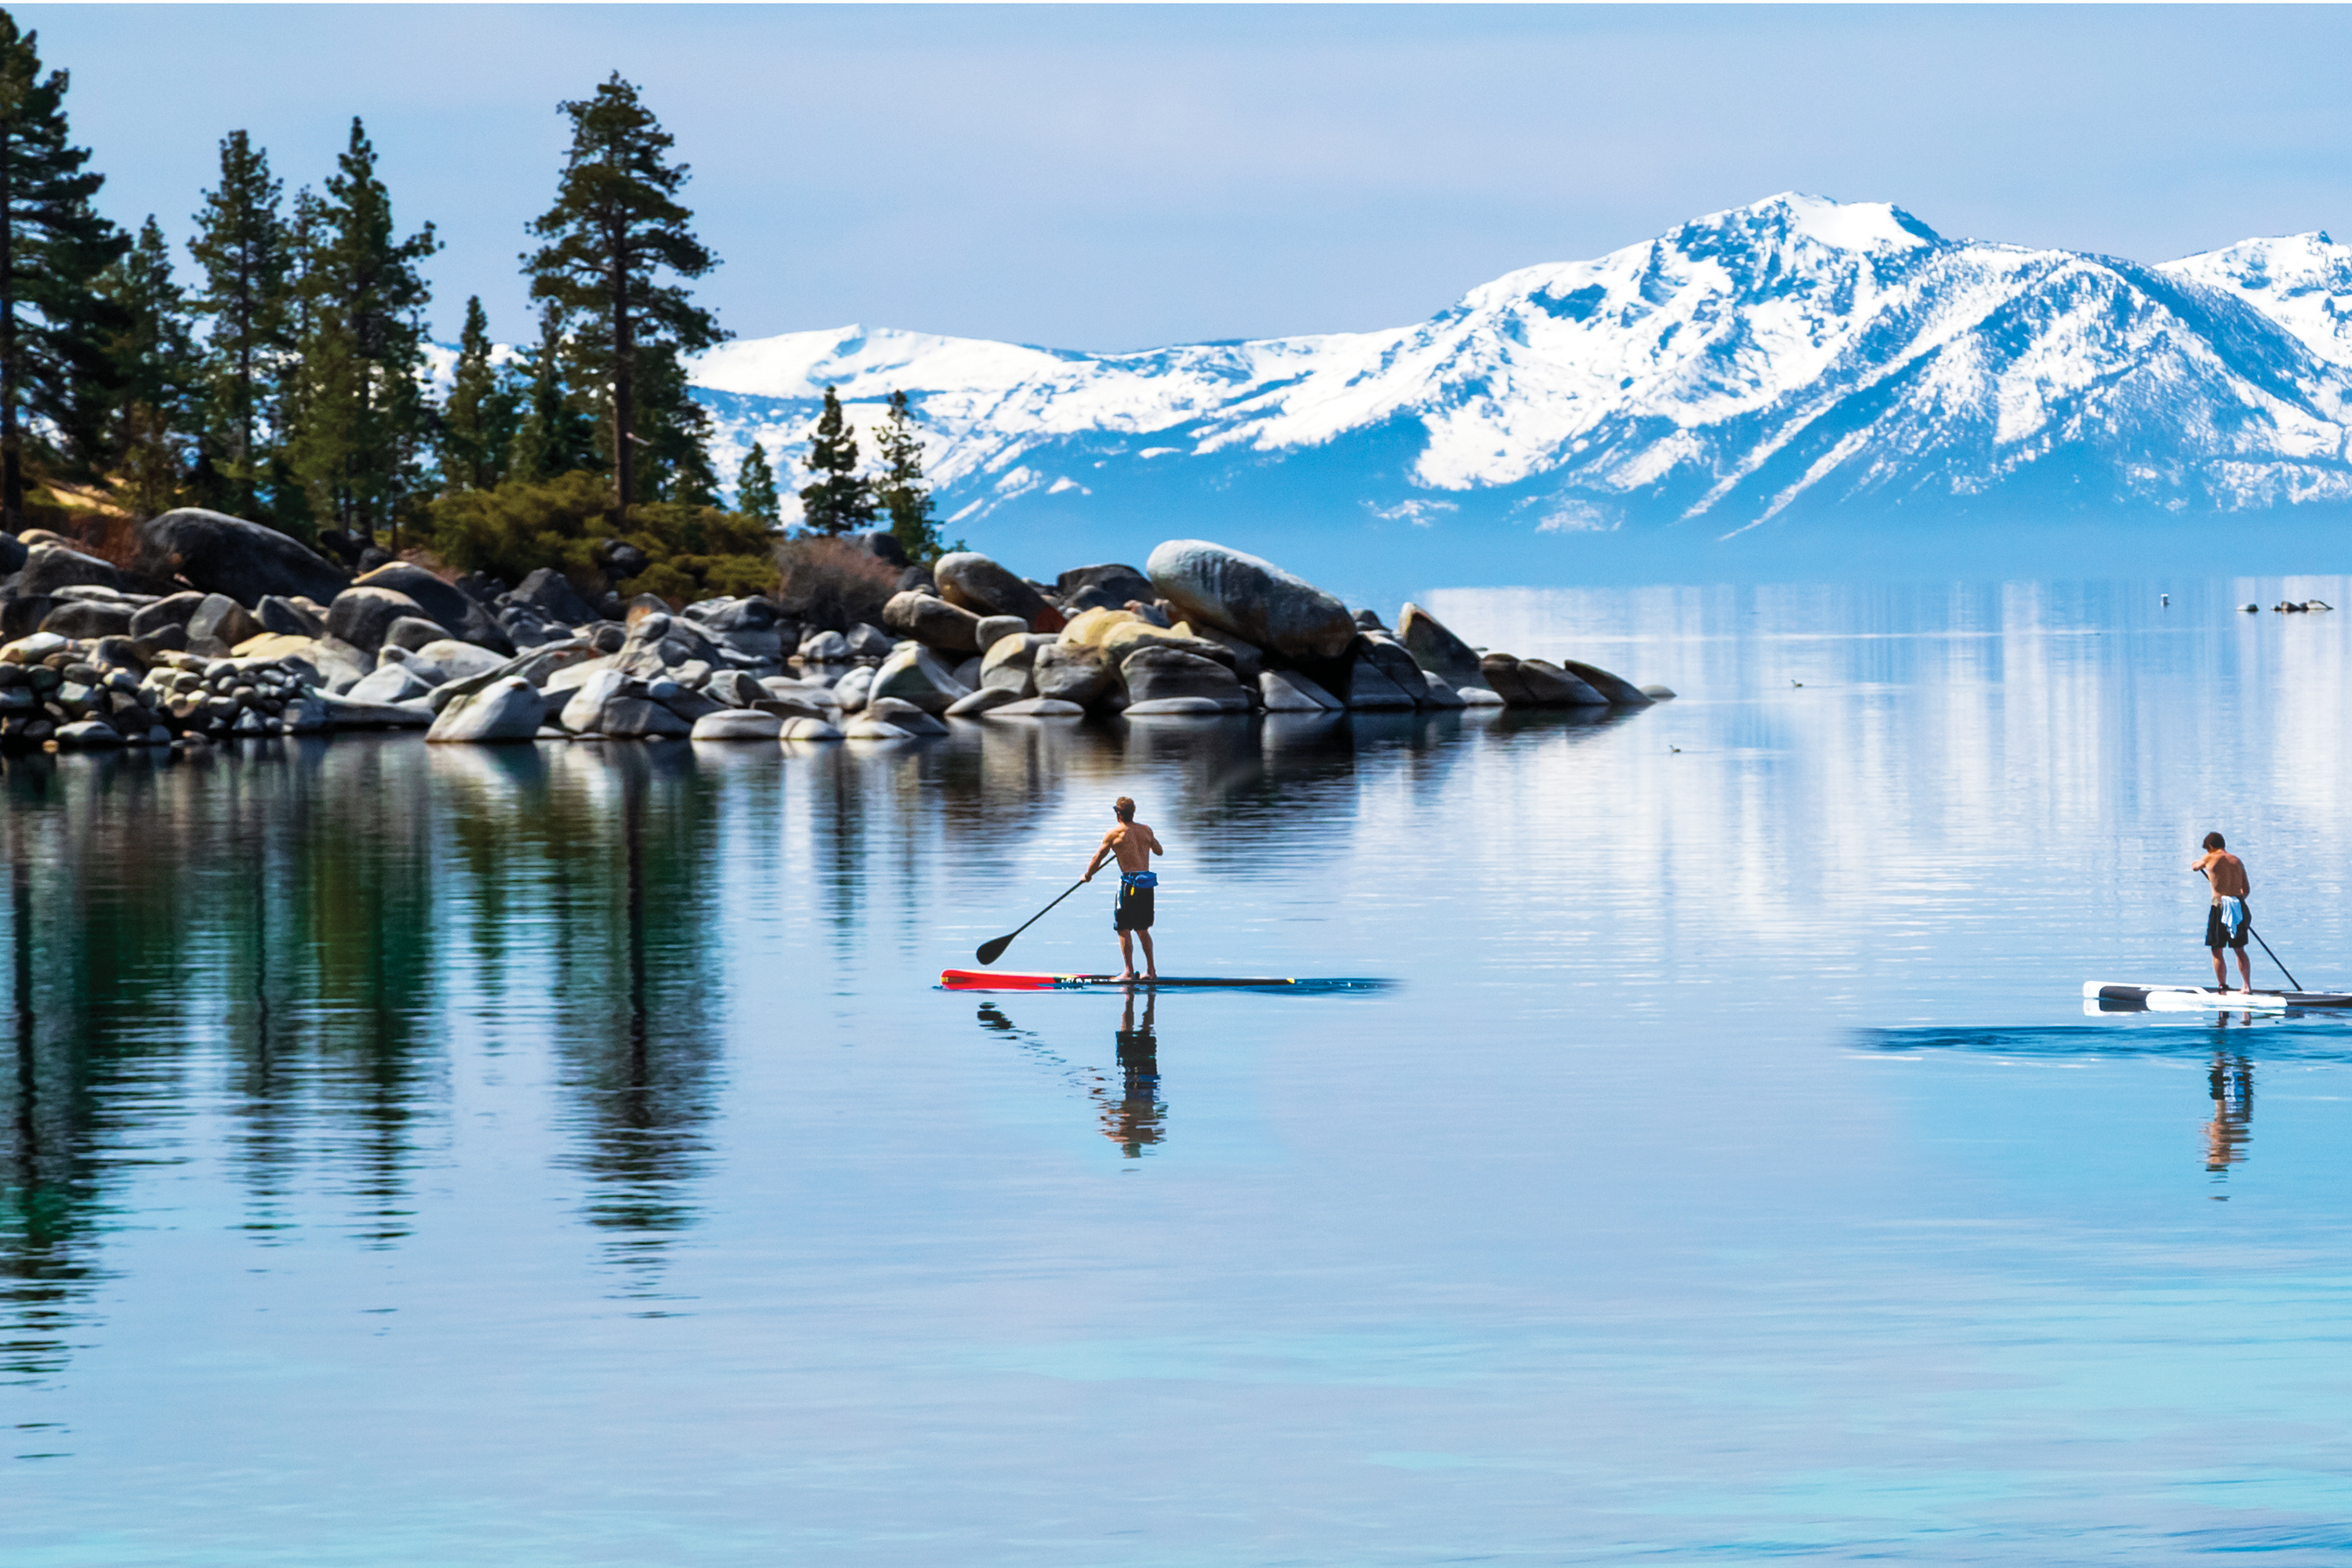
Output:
top-left (433, 472), bottom-right (776, 605)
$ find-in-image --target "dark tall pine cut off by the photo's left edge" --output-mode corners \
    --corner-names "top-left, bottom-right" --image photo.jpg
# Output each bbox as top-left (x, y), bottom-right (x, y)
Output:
top-left (0, 11), bottom-right (130, 534)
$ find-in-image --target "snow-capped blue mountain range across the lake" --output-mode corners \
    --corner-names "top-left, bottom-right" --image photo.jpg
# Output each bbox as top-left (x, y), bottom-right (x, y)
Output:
top-left (694, 195), bottom-right (2352, 561)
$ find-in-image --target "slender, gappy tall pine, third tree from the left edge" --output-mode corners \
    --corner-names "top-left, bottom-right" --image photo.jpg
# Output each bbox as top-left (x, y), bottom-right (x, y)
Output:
top-left (188, 132), bottom-right (292, 517)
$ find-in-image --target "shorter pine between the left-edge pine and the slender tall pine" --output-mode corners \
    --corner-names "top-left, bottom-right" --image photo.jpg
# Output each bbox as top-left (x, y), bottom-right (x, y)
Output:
top-left (97, 214), bottom-right (195, 517)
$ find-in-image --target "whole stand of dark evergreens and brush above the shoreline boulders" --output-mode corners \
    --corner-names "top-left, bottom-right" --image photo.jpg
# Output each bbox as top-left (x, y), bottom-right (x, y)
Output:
top-left (0, 10), bottom-right (943, 625)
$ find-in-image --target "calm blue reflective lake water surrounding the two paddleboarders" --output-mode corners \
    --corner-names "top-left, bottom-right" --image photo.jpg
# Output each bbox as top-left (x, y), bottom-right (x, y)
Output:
top-left (0, 578), bottom-right (2352, 1568)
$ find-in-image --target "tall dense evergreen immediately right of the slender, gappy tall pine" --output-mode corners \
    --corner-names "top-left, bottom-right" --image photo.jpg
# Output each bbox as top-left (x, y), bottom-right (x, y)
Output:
top-left (292, 120), bottom-right (440, 541)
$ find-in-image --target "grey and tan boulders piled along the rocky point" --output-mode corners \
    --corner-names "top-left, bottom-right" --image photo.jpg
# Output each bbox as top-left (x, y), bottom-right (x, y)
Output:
top-left (0, 510), bottom-right (1673, 750)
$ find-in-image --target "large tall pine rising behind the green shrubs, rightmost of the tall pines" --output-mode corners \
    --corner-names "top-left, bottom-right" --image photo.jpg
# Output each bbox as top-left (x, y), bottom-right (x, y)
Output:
top-left (522, 71), bottom-right (727, 508)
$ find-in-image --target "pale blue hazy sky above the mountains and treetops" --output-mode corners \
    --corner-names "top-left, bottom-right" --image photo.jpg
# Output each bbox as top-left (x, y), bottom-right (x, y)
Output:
top-left (17, 4), bottom-right (2352, 348)
